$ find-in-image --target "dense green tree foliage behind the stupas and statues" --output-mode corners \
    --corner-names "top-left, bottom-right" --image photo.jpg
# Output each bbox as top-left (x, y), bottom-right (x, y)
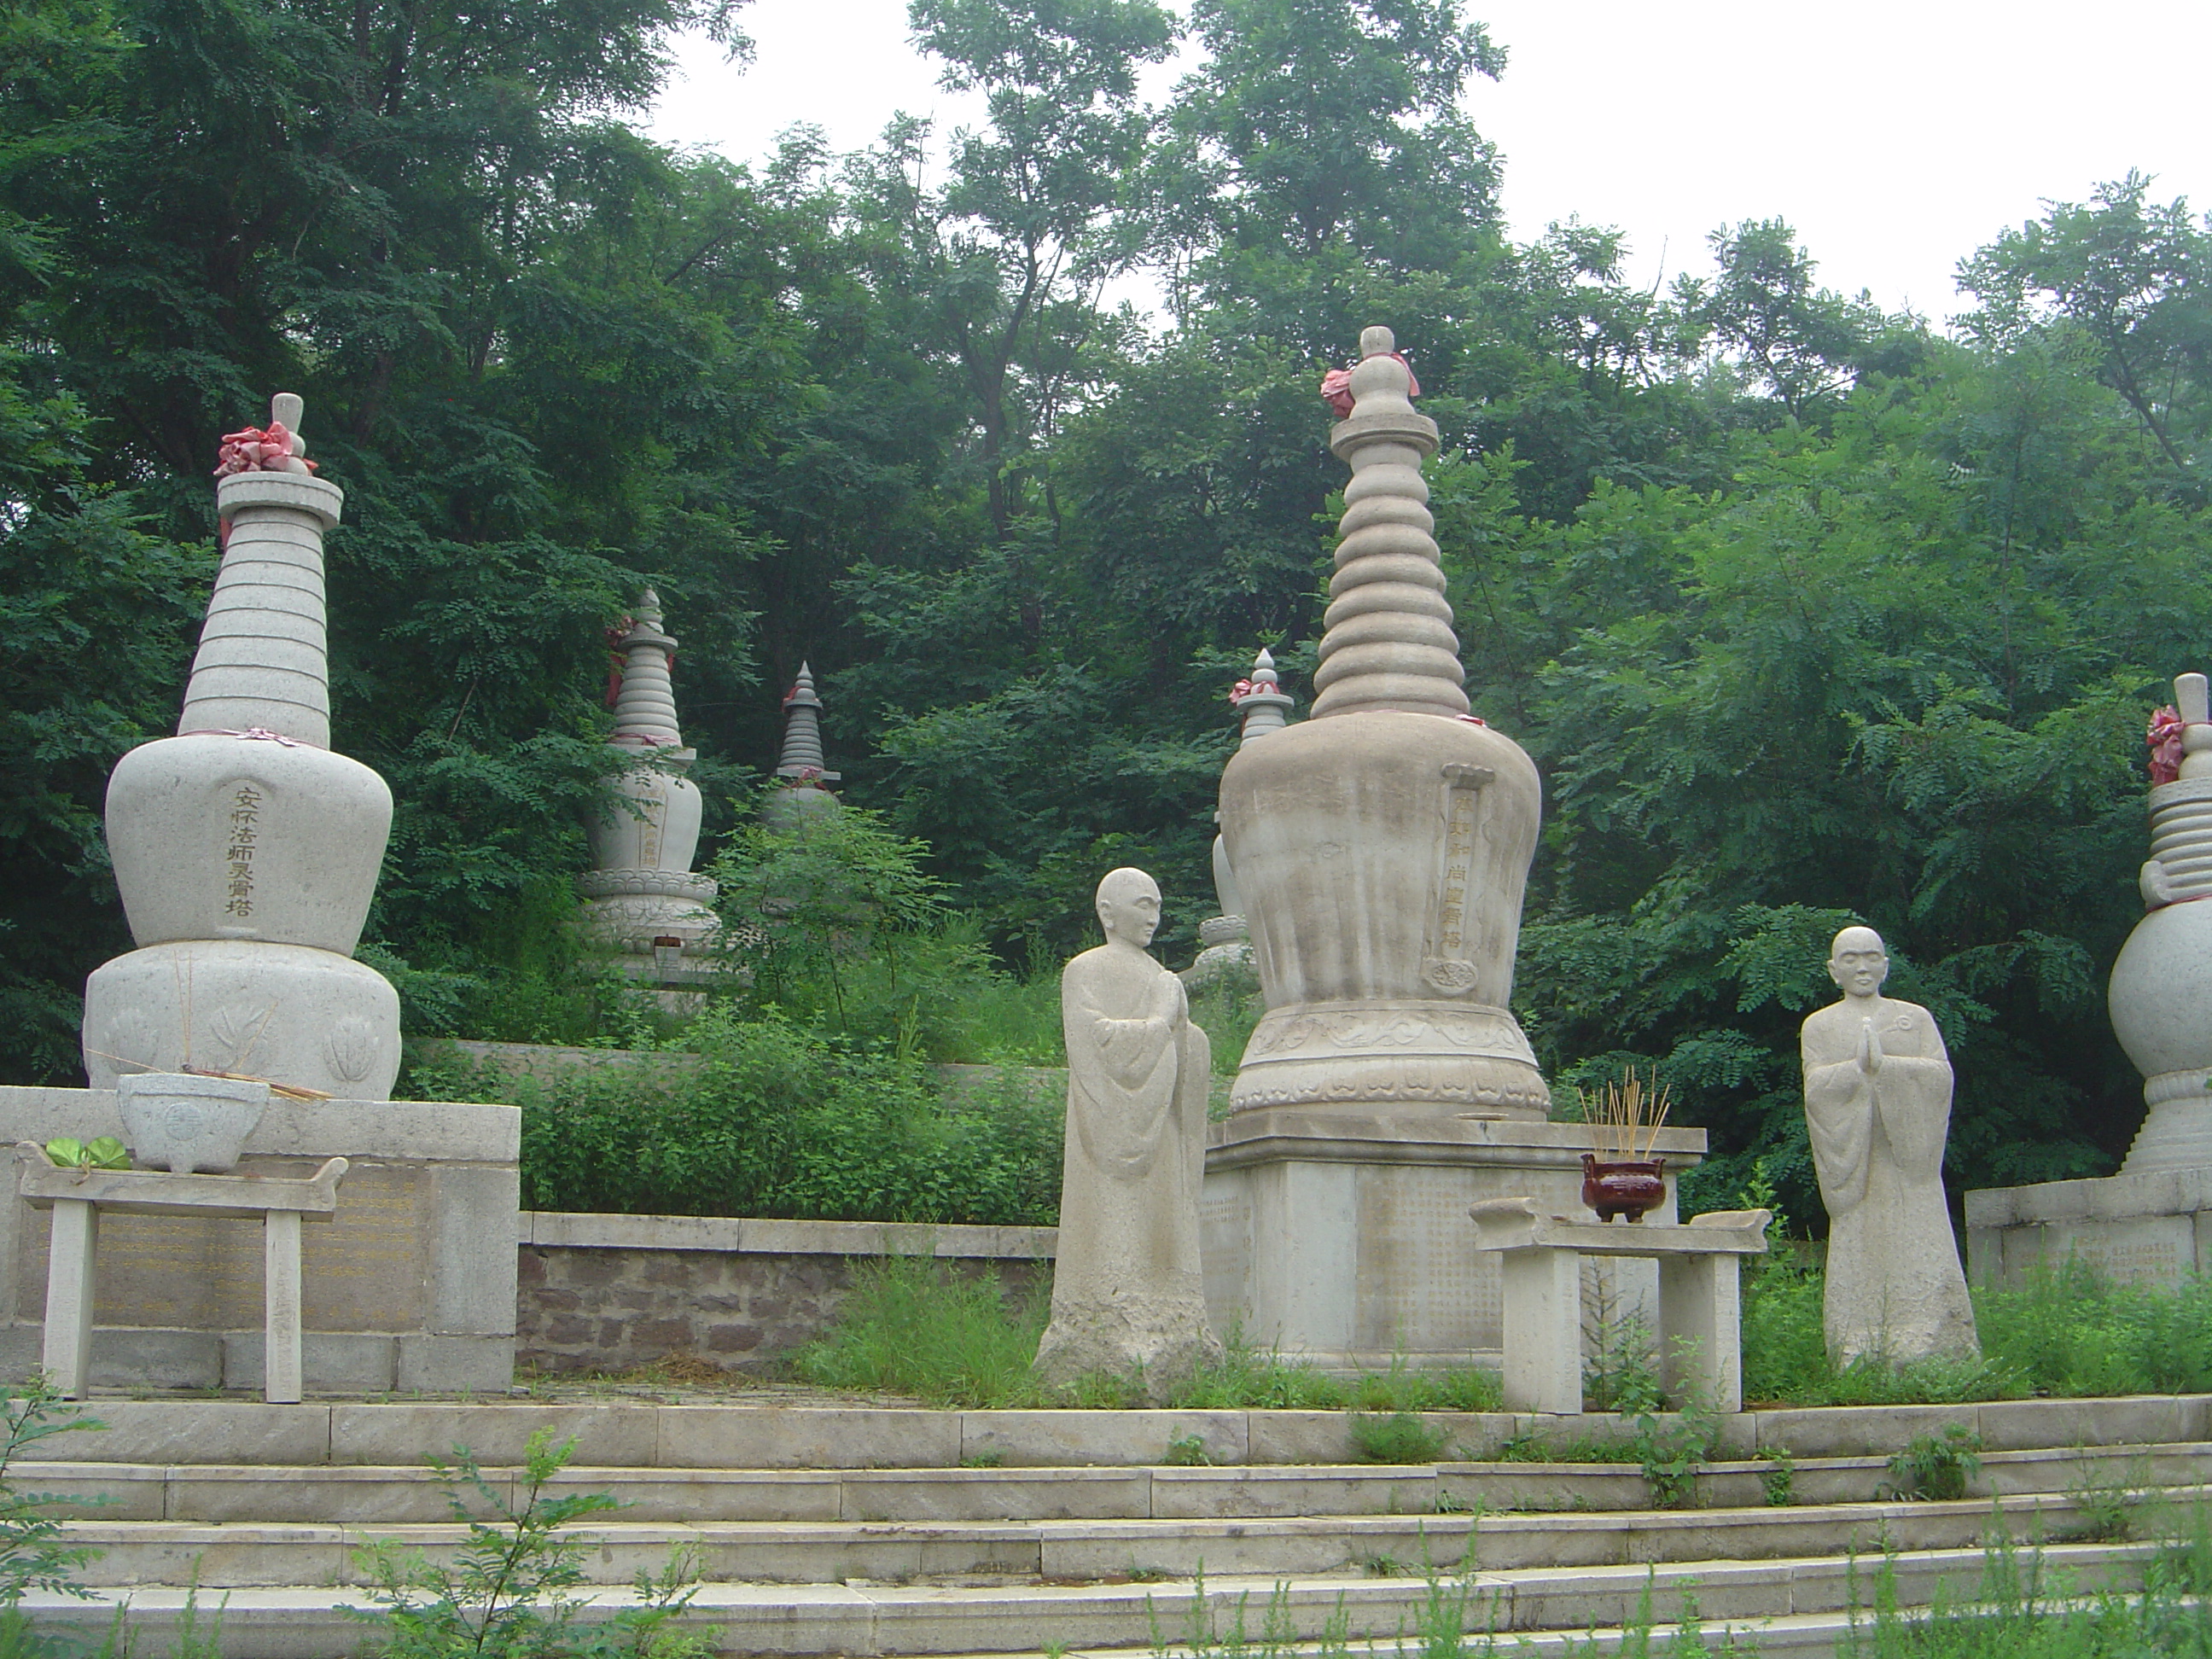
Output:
top-left (0, 0), bottom-right (2212, 1214)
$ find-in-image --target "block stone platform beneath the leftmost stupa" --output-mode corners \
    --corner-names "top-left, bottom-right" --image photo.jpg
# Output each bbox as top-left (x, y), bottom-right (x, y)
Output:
top-left (0, 1088), bottom-right (522, 1394)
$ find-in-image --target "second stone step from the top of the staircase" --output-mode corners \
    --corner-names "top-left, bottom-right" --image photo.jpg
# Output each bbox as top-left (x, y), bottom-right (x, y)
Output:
top-left (15, 1442), bottom-right (2212, 1524)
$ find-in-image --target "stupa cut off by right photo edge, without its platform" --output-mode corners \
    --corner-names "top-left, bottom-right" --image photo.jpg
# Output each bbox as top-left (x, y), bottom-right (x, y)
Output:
top-left (2106, 675), bottom-right (2212, 1174)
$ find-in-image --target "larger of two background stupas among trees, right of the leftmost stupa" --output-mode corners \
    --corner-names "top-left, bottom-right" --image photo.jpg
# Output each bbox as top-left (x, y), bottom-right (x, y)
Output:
top-left (575, 588), bottom-right (721, 980)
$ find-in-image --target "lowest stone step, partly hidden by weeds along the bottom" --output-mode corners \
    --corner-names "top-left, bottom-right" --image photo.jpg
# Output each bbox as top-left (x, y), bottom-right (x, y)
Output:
top-left (25, 1544), bottom-right (2155, 1659)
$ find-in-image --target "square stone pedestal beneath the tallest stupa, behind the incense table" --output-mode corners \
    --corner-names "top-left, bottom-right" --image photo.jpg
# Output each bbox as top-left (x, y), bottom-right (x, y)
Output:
top-left (1201, 1106), bottom-right (1705, 1369)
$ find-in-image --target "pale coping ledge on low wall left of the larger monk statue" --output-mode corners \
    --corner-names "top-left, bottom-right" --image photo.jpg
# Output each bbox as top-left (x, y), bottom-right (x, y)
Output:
top-left (515, 1210), bottom-right (1060, 1260)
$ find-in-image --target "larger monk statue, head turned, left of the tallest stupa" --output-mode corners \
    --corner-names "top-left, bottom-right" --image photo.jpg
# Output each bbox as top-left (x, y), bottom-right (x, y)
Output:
top-left (1035, 870), bottom-right (1221, 1400)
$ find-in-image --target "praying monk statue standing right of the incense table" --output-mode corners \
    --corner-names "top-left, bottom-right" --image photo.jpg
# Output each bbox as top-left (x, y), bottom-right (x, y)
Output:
top-left (1801, 927), bottom-right (1980, 1365)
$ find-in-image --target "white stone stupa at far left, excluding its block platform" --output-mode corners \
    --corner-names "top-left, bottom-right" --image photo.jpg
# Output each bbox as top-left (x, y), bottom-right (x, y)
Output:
top-left (84, 393), bottom-right (400, 1099)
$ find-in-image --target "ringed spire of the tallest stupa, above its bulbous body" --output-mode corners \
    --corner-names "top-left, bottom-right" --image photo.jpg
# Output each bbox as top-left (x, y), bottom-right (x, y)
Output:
top-left (1314, 328), bottom-right (1466, 719)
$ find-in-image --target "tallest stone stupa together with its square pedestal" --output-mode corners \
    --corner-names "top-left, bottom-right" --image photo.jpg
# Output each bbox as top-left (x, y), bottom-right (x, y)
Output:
top-left (1206, 328), bottom-right (1703, 1367)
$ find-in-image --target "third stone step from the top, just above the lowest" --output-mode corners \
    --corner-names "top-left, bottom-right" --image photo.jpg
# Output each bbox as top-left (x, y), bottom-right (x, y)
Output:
top-left (43, 1487), bottom-right (2168, 1588)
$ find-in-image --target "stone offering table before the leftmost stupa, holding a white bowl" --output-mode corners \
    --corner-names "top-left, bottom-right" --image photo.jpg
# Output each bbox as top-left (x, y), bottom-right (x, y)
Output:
top-left (15, 1141), bottom-right (345, 1405)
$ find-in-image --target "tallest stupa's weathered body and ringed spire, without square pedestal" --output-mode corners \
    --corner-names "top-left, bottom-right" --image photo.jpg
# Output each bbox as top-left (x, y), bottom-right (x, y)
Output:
top-left (1221, 329), bottom-right (1551, 1117)
